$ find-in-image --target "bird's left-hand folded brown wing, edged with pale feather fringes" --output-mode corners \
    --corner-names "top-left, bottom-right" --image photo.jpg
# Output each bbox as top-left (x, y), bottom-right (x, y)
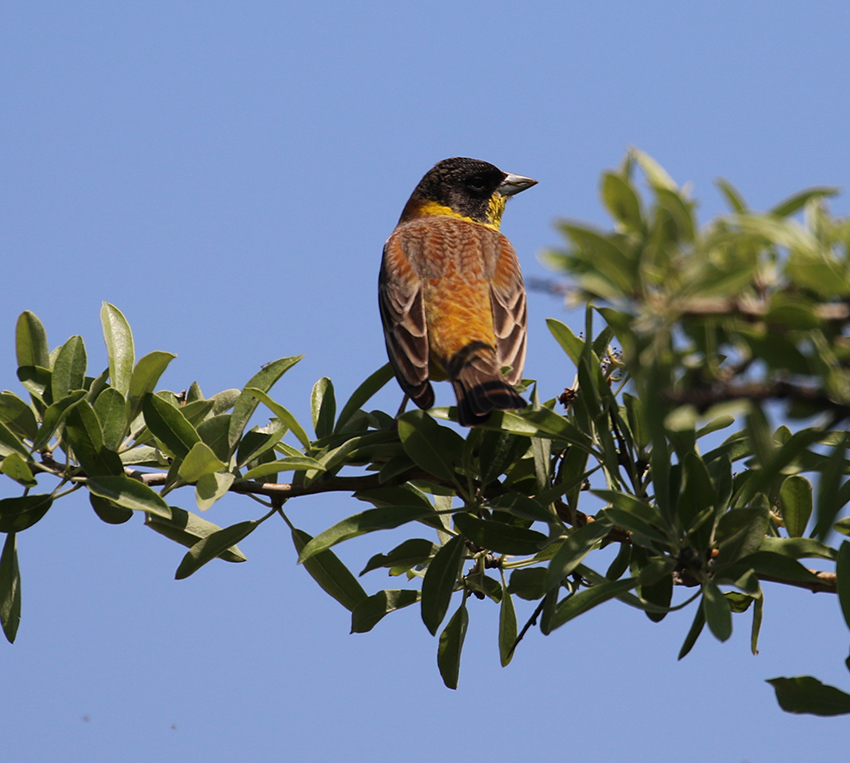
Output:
top-left (378, 234), bottom-right (434, 408)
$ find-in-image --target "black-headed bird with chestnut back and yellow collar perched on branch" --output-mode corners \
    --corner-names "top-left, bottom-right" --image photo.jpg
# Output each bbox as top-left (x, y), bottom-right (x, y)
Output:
top-left (378, 157), bottom-right (537, 426)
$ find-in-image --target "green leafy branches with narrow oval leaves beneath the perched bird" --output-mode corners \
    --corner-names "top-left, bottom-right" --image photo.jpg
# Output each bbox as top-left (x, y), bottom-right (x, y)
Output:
top-left (0, 151), bottom-right (850, 715)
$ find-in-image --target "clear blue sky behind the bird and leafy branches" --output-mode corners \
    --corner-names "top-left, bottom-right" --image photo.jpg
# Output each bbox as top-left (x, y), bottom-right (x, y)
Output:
top-left (0, 0), bottom-right (850, 763)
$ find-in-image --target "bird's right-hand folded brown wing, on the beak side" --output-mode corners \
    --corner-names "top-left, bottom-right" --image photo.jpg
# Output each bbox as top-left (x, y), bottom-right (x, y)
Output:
top-left (490, 236), bottom-right (528, 384)
